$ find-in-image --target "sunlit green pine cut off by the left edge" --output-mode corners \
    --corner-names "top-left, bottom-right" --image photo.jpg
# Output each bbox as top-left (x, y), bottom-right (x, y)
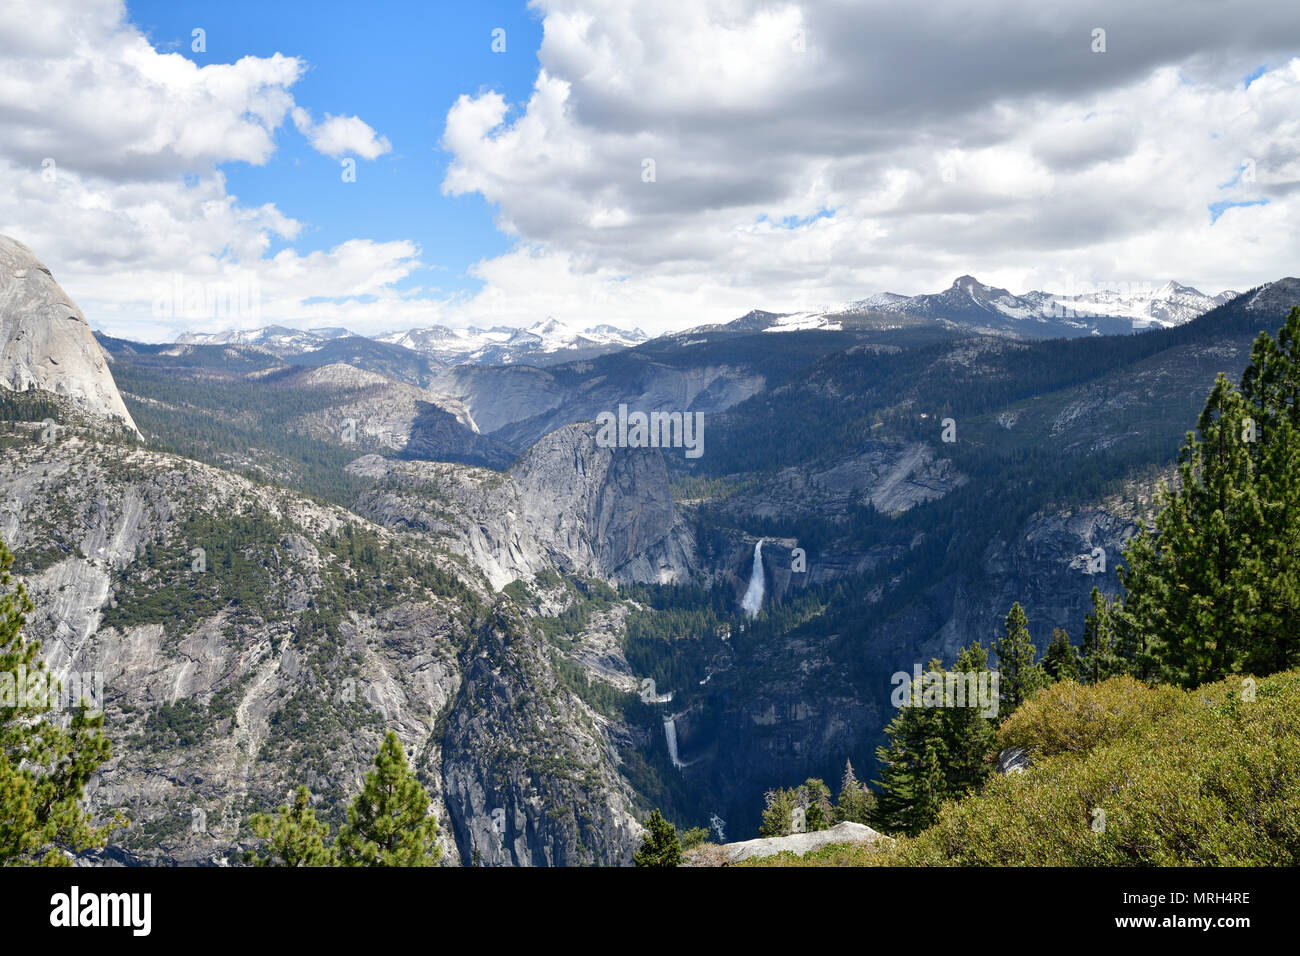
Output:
top-left (0, 542), bottom-right (121, 866)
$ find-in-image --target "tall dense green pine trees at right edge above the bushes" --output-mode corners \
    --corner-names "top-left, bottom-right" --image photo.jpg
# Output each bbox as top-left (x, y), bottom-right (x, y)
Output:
top-left (1113, 307), bottom-right (1300, 687)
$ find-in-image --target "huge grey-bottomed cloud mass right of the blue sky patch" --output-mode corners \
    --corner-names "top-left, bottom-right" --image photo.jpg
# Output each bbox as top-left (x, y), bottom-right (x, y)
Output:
top-left (443, 0), bottom-right (1300, 328)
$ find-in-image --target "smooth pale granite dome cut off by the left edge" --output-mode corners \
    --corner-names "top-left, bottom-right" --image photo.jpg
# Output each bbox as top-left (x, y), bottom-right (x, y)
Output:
top-left (0, 235), bottom-right (137, 432)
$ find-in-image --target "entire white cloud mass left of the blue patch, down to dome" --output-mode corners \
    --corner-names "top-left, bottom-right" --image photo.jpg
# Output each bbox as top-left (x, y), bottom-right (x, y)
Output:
top-left (0, 0), bottom-right (403, 338)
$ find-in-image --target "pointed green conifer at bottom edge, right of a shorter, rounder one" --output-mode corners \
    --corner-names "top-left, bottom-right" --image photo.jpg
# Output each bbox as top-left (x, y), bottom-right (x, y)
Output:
top-left (338, 731), bottom-right (442, 866)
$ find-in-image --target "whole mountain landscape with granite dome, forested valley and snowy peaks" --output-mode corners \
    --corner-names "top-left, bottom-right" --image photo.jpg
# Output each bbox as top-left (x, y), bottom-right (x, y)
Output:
top-left (0, 234), bottom-right (1300, 865)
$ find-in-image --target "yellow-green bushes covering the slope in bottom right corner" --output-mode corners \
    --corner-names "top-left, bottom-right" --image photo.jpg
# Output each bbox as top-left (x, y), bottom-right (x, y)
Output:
top-left (862, 671), bottom-right (1300, 866)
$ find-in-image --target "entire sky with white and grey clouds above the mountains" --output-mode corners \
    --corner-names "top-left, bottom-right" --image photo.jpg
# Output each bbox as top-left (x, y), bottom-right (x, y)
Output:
top-left (0, 0), bottom-right (1300, 341)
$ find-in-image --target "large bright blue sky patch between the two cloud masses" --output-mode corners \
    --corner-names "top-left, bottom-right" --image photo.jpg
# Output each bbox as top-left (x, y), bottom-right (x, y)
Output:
top-left (127, 0), bottom-right (542, 299)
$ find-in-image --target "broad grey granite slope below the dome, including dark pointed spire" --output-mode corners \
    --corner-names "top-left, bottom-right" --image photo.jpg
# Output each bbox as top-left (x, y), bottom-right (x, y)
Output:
top-left (0, 424), bottom-right (640, 865)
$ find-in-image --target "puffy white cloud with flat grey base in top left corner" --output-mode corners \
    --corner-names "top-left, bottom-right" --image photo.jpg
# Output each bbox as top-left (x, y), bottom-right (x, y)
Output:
top-left (0, 0), bottom-right (303, 181)
